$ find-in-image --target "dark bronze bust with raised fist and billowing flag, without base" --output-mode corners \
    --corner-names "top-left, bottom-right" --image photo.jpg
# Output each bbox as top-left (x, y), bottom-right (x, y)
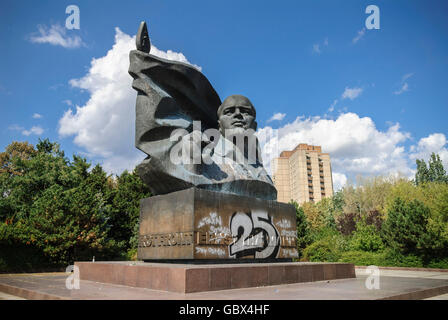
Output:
top-left (129, 22), bottom-right (277, 200)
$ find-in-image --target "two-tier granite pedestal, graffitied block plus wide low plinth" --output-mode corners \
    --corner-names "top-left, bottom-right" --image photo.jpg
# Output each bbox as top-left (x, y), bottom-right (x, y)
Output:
top-left (75, 188), bottom-right (355, 293)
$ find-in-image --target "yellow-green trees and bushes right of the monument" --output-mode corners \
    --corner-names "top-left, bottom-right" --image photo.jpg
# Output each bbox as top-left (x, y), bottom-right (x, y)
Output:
top-left (299, 154), bottom-right (448, 268)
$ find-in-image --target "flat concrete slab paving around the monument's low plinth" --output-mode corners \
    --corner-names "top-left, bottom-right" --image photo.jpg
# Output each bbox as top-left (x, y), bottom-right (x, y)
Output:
top-left (0, 269), bottom-right (448, 300)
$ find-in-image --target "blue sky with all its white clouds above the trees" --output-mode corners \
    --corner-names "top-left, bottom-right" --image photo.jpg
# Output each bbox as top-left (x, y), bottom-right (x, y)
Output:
top-left (0, 0), bottom-right (448, 187)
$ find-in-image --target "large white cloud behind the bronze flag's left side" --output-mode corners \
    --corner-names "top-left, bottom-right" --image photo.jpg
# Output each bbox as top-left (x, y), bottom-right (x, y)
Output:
top-left (58, 28), bottom-right (200, 174)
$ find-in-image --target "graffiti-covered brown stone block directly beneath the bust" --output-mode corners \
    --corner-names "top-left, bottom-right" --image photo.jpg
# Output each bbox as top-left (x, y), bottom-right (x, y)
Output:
top-left (138, 188), bottom-right (298, 261)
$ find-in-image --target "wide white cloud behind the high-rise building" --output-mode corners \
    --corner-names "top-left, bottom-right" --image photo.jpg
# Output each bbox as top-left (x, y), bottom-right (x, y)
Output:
top-left (257, 113), bottom-right (413, 186)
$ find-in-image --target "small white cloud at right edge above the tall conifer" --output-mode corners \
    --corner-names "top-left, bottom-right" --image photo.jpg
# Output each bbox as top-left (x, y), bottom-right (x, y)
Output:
top-left (410, 133), bottom-right (448, 168)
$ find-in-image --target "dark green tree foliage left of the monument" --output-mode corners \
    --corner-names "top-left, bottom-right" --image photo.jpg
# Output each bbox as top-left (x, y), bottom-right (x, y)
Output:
top-left (0, 139), bottom-right (149, 265)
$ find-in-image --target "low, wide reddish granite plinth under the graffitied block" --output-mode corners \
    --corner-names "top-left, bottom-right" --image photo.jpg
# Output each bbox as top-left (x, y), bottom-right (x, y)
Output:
top-left (75, 262), bottom-right (356, 293)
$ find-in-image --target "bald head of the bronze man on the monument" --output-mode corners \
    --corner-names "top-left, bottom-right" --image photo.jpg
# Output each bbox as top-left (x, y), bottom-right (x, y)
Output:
top-left (217, 95), bottom-right (257, 134)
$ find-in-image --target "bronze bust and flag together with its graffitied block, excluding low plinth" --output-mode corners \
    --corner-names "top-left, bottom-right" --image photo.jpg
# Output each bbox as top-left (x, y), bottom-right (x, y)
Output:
top-left (129, 22), bottom-right (297, 261)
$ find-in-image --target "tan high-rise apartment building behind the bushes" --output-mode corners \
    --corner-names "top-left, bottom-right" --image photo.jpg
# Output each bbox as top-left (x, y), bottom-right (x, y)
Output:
top-left (271, 144), bottom-right (333, 204)
